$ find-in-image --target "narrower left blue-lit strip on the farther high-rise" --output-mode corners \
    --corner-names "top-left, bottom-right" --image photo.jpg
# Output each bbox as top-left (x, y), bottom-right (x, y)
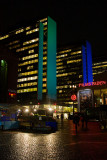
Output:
top-left (82, 45), bottom-right (87, 83)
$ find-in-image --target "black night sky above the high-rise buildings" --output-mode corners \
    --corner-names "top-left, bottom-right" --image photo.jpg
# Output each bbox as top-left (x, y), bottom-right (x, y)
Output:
top-left (0, 0), bottom-right (107, 57)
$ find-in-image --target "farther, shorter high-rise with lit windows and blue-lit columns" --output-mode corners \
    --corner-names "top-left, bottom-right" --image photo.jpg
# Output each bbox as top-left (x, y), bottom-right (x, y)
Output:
top-left (57, 41), bottom-right (93, 106)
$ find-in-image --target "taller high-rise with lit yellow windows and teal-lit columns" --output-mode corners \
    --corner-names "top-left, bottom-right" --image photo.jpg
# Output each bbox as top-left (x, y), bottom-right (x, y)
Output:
top-left (0, 17), bottom-right (57, 104)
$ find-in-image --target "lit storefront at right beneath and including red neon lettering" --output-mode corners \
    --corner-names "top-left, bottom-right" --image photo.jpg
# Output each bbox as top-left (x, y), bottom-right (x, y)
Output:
top-left (77, 81), bottom-right (107, 111)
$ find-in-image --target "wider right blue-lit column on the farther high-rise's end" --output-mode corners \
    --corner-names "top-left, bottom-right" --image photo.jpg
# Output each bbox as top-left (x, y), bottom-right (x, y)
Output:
top-left (86, 41), bottom-right (93, 82)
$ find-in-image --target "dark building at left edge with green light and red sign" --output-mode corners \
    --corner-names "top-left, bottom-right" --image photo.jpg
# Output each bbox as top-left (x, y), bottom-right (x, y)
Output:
top-left (0, 46), bottom-right (18, 103)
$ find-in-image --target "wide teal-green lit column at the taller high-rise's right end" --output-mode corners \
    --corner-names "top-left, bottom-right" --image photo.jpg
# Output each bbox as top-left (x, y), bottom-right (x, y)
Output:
top-left (47, 17), bottom-right (57, 100)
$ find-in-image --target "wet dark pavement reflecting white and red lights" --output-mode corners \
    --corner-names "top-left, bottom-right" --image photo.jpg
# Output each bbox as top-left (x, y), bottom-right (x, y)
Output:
top-left (0, 120), bottom-right (107, 160)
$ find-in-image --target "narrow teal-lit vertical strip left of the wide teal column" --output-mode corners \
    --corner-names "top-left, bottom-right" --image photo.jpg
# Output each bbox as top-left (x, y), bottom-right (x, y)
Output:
top-left (38, 22), bottom-right (44, 100)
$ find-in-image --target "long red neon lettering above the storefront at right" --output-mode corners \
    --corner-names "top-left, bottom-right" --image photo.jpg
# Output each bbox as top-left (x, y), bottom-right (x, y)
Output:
top-left (79, 81), bottom-right (107, 87)
